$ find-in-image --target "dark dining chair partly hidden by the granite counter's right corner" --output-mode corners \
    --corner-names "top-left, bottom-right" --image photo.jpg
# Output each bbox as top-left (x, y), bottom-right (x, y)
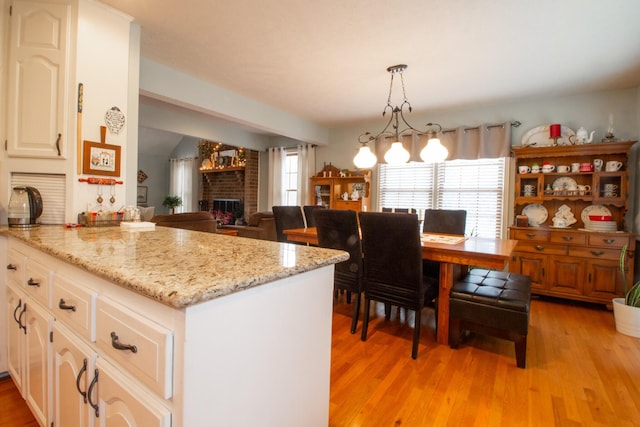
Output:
top-left (314, 209), bottom-right (362, 334)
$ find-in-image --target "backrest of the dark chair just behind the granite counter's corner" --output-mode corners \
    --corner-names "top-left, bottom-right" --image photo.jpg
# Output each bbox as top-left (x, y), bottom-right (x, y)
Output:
top-left (314, 209), bottom-right (362, 280)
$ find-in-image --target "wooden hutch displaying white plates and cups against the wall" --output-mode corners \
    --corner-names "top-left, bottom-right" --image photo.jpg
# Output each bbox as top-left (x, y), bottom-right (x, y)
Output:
top-left (509, 141), bottom-right (636, 308)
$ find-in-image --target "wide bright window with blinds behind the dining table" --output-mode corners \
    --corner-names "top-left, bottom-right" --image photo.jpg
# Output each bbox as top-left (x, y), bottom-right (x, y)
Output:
top-left (378, 158), bottom-right (506, 237)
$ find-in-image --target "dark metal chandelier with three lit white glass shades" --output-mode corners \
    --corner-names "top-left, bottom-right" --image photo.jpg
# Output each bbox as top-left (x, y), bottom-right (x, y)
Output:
top-left (353, 64), bottom-right (449, 169)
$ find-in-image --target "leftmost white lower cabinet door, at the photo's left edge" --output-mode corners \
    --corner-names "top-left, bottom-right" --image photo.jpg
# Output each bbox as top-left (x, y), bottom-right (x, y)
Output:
top-left (7, 282), bottom-right (26, 397)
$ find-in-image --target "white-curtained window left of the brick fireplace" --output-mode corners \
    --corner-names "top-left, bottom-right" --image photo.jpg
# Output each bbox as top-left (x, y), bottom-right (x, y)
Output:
top-left (169, 157), bottom-right (198, 213)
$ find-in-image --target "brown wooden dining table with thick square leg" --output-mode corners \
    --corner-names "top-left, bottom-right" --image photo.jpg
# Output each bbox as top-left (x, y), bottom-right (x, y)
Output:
top-left (283, 227), bottom-right (518, 344)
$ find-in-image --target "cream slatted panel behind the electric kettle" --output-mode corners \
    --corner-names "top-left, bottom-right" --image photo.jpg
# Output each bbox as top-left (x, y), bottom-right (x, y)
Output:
top-left (11, 172), bottom-right (66, 224)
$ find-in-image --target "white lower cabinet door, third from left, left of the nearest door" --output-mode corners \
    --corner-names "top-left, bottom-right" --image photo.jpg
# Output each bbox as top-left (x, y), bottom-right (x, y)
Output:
top-left (53, 322), bottom-right (97, 427)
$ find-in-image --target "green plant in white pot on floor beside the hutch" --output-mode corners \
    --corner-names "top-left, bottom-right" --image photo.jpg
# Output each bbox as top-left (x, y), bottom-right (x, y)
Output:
top-left (613, 245), bottom-right (640, 338)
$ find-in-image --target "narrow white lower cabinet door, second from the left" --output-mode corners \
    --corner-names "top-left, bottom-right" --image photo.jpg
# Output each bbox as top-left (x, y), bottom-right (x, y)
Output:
top-left (25, 300), bottom-right (53, 425)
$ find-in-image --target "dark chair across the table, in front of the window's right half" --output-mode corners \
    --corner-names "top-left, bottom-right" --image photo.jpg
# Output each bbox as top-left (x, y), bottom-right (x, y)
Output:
top-left (422, 209), bottom-right (467, 305)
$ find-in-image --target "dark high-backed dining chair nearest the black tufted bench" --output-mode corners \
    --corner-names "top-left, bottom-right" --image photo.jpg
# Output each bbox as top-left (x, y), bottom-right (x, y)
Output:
top-left (358, 212), bottom-right (427, 359)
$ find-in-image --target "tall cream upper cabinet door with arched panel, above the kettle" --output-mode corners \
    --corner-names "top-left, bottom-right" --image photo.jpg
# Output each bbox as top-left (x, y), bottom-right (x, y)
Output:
top-left (7, 1), bottom-right (71, 158)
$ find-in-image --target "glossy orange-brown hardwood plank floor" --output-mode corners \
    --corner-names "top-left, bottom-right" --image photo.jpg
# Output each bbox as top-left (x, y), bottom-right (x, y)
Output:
top-left (0, 296), bottom-right (640, 427)
